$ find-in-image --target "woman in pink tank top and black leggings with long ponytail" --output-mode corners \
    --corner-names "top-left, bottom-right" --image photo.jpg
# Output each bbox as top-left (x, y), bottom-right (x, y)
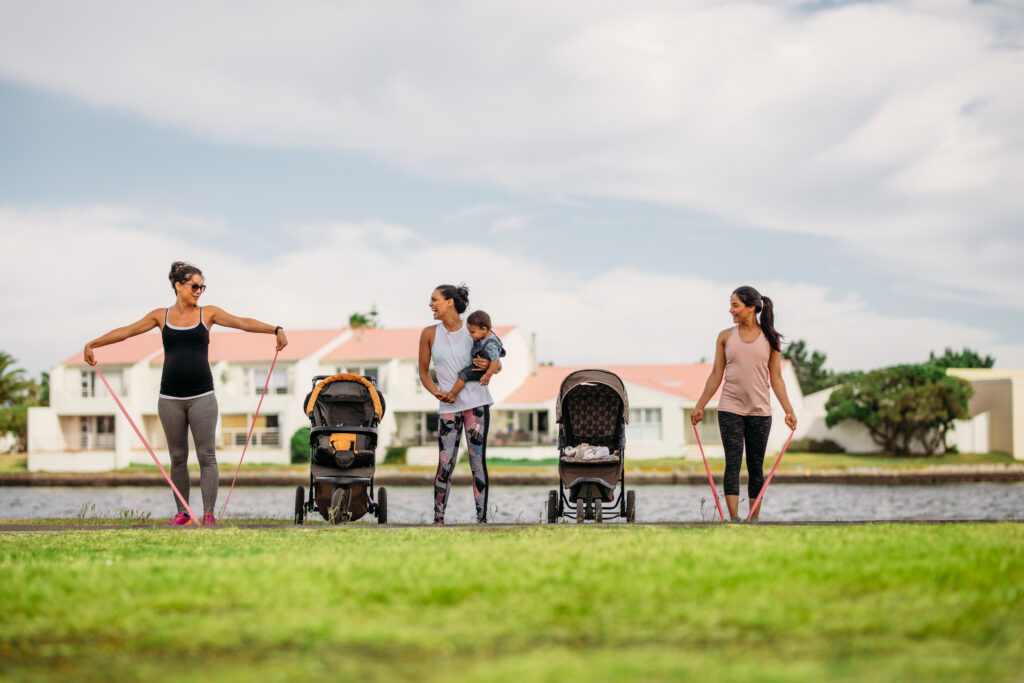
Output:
top-left (690, 286), bottom-right (797, 521)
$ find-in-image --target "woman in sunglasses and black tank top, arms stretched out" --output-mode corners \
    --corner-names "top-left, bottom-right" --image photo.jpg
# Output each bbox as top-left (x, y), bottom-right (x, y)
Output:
top-left (85, 261), bottom-right (288, 525)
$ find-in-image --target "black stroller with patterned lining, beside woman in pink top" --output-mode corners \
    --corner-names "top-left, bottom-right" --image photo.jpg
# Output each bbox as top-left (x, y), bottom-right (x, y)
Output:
top-left (548, 370), bottom-right (636, 523)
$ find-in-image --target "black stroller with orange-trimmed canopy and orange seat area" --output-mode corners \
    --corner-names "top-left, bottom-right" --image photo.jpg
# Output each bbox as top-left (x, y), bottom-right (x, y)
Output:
top-left (295, 373), bottom-right (387, 524)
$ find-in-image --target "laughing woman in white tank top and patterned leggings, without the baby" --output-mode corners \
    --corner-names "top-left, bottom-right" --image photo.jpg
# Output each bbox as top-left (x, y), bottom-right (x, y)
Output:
top-left (419, 285), bottom-right (501, 524)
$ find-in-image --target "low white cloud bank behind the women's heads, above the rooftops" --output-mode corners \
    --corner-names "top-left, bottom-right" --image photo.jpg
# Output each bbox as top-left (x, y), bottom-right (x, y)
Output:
top-left (0, 206), bottom-right (1024, 373)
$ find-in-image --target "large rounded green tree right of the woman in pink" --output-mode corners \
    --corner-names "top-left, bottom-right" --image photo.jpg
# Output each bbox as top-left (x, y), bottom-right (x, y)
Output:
top-left (825, 364), bottom-right (974, 456)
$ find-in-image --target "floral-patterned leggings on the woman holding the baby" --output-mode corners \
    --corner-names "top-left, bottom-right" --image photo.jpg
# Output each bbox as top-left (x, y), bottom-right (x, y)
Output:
top-left (434, 405), bottom-right (490, 522)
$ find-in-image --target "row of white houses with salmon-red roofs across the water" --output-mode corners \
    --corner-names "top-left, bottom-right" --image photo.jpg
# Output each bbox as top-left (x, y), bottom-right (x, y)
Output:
top-left (29, 327), bottom-right (803, 471)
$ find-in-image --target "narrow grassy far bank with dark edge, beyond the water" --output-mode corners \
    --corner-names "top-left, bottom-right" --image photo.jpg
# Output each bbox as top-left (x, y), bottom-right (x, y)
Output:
top-left (0, 465), bottom-right (1024, 487)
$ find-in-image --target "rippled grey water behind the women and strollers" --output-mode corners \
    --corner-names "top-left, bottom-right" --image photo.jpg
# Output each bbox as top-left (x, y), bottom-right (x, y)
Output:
top-left (0, 482), bottom-right (1024, 523)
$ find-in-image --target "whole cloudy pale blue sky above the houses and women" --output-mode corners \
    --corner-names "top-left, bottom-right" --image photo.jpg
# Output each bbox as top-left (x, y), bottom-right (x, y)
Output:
top-left (0, 0), bottom-right (1024, 375)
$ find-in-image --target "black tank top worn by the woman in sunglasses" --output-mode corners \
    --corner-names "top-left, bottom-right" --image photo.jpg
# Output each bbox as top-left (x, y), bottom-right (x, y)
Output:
top-left (160, 308), bottom-right (213, 398)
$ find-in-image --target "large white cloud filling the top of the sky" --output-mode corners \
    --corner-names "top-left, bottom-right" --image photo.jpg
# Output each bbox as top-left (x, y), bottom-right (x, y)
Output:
top-left (0, 0), bottom-right (1024, 306)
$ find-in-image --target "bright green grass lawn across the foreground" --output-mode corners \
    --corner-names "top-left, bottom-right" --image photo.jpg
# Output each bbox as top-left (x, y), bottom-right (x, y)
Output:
top-left (0, 523), bottom-right (1024, 681)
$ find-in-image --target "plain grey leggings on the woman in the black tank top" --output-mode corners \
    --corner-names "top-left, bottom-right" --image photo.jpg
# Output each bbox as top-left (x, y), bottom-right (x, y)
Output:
top-left (157, 393), bottom-right (220, 512)
